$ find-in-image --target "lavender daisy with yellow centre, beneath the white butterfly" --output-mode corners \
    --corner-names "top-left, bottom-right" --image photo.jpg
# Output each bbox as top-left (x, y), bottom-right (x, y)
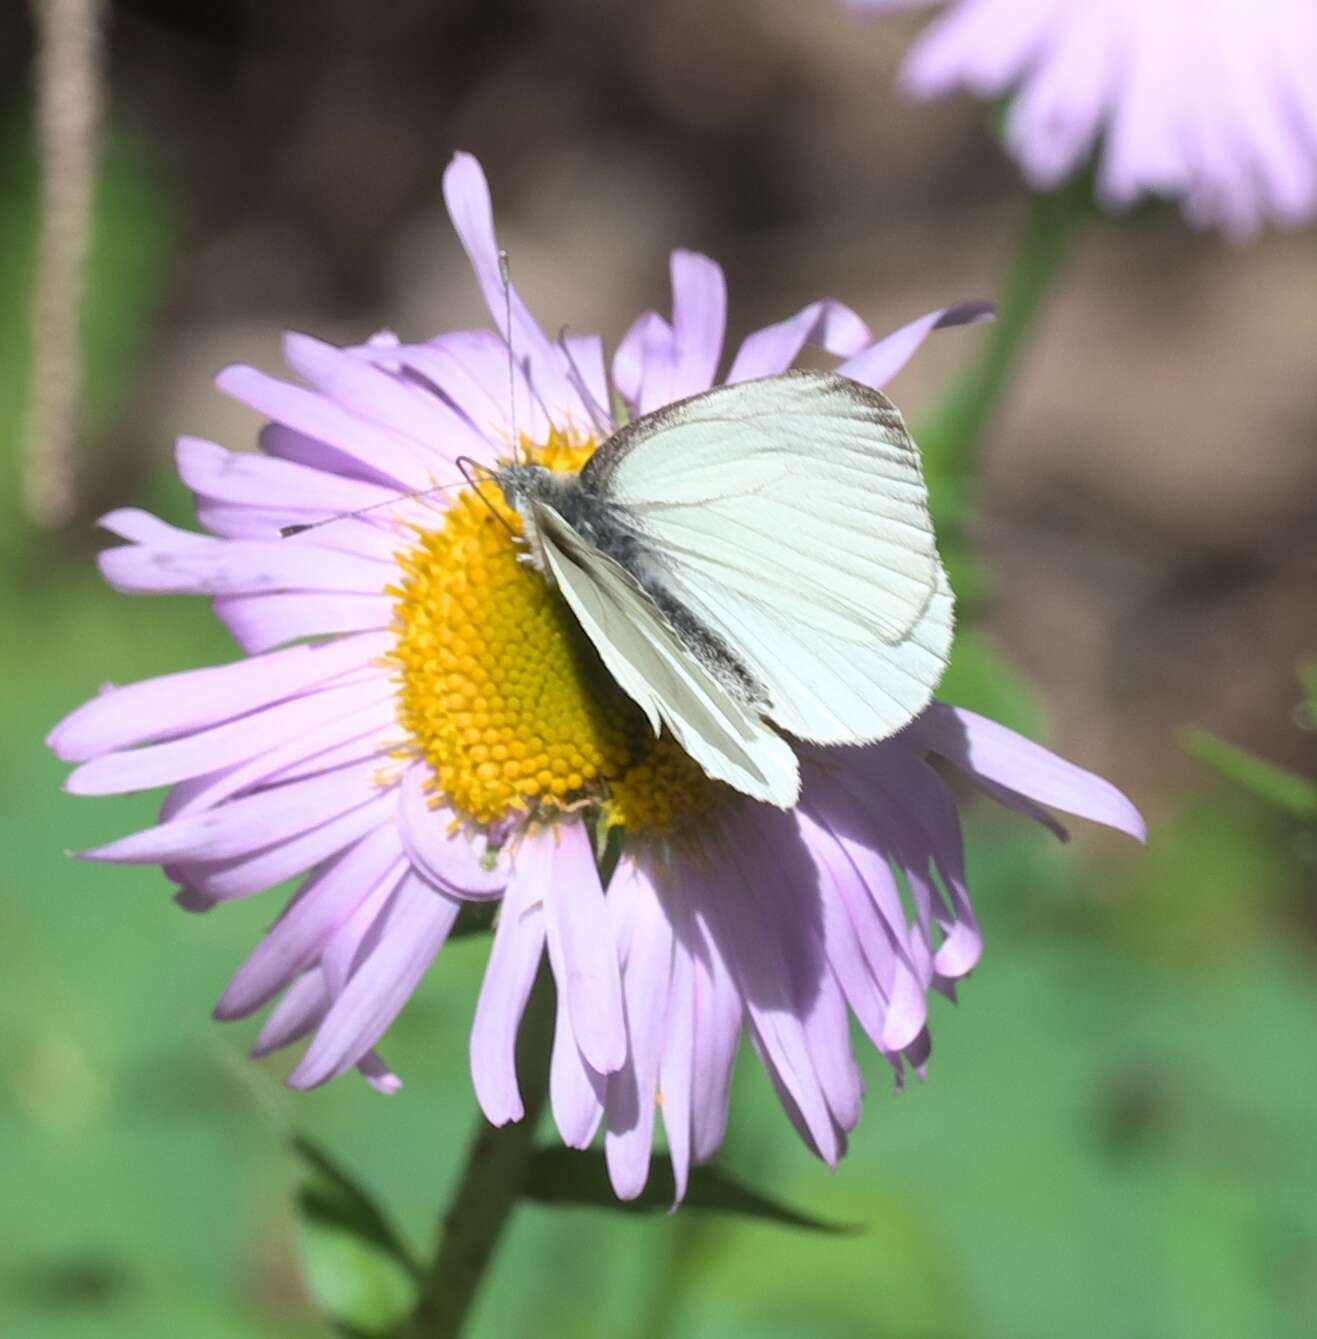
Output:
top-left (51, 155), bottom-right (1143, 1197)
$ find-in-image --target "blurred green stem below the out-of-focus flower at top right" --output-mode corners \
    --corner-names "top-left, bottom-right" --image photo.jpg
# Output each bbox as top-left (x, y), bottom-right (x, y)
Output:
top-left (919, 174), bottom-right (1092, 532)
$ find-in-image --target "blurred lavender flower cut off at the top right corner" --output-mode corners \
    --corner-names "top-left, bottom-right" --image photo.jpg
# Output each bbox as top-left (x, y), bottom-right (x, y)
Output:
top-left (850, 0), bottom-right (1317, 240)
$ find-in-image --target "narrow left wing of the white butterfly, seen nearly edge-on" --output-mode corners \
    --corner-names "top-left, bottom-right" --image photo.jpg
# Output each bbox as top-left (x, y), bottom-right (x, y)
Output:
top-left (530, 501), bottom-right (800, 809)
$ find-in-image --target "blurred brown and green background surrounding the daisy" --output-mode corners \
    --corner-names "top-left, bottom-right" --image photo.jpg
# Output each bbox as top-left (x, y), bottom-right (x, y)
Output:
top-left (0, 0), bottom-right (1317, 1339)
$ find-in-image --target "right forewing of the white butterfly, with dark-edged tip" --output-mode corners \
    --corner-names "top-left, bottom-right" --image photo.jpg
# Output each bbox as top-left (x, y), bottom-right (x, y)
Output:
top-left (581, 371), bottom-right (940, 643)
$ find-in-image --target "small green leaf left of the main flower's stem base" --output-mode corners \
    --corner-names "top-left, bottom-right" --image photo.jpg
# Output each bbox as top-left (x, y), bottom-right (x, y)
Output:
top-left (292, 1135), bottom-right (420, 1336)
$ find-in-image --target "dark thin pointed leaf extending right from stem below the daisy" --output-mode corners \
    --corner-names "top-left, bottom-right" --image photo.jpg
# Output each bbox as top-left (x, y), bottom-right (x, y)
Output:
top-left (522, 1148), bottom-right (861, 1233)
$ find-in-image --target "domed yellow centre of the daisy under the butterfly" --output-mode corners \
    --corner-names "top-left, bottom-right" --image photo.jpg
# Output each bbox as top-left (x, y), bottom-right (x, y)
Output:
top-left (389, 431), bottom-right (728, 834)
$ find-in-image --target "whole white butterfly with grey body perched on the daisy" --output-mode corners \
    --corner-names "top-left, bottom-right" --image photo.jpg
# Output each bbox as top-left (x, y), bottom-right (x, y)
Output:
top-left (495, 371), bottom-right (953, 807)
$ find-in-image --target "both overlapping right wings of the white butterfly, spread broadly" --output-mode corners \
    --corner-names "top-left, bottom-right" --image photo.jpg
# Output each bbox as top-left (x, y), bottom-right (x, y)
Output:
top-left (591, 371), bottom-right (953, 743)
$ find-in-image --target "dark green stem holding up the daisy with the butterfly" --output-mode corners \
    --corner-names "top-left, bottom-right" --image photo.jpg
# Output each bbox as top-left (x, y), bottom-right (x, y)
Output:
top-left (398, 968), bottom-right (554, 1339)
